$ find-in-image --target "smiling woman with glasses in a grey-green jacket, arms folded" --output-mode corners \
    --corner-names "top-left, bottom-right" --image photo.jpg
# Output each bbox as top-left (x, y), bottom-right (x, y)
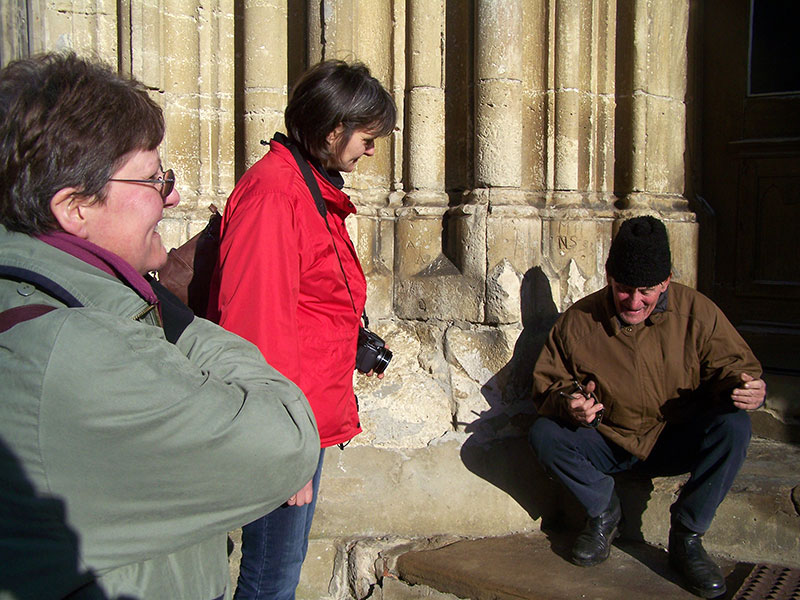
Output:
top-left (0, 54), bottom-right (319, 600)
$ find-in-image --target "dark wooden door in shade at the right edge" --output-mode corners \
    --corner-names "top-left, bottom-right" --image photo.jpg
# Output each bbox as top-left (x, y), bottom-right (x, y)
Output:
top-left (700, 0), bottom-right (800, 377)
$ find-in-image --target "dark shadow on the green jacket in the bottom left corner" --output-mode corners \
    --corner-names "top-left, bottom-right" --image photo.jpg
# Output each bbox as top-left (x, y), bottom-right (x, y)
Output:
top-left (0, 438), bottom-right (115, 600)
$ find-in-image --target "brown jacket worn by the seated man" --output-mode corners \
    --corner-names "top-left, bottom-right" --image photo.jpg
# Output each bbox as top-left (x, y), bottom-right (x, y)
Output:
top-left (533, 283), bottom-right (761, 459)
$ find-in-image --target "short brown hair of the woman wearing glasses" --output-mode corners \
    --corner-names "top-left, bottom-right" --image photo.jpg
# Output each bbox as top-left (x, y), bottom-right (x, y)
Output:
top-left (0, 53), bottom-right (164, 234)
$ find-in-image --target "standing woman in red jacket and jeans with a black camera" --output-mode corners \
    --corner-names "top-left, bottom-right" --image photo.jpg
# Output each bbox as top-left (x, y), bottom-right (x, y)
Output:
top-left (210, 61), bottom-right (396, 600)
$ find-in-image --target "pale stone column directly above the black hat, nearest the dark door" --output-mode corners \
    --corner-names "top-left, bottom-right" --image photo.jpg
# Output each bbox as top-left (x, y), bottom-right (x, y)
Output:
top-left (615, 0), bottom-right (697, 285)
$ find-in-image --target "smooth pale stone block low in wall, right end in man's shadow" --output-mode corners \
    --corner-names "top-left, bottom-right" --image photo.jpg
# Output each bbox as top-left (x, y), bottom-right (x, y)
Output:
top-left (311, 433), bottom-right (537, 538)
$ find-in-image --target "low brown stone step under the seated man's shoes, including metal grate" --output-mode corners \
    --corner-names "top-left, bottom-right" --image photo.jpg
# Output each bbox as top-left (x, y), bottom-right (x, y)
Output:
top-left (394, 534), bottom-right (800, 600)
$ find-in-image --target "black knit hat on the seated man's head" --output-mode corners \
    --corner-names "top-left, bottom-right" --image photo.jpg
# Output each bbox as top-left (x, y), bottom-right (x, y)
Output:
top-left (606, 217), bottom-right (672, 287)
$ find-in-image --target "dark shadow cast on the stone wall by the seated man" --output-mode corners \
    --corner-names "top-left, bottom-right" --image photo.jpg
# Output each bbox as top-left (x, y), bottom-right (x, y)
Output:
top-left (461, 267), bottom-right (582, 529)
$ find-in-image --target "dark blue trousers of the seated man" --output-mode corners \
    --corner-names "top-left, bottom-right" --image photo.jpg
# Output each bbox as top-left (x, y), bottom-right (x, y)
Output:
top-left (528, 410), bottom-right (750, 533)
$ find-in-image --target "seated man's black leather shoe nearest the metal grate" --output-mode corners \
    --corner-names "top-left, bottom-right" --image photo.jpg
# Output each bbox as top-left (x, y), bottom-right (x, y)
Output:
top-left (669, 522), bottom-right (727, 598)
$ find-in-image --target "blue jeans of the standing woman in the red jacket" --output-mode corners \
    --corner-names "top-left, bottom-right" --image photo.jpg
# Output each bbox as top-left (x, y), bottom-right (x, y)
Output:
top-left (234, 448), bottom-right (325, 600)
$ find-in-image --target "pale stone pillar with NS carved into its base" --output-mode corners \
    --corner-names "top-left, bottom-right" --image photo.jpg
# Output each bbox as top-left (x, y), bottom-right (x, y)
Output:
top-left (542, 0), bottom-right (616, 310)
